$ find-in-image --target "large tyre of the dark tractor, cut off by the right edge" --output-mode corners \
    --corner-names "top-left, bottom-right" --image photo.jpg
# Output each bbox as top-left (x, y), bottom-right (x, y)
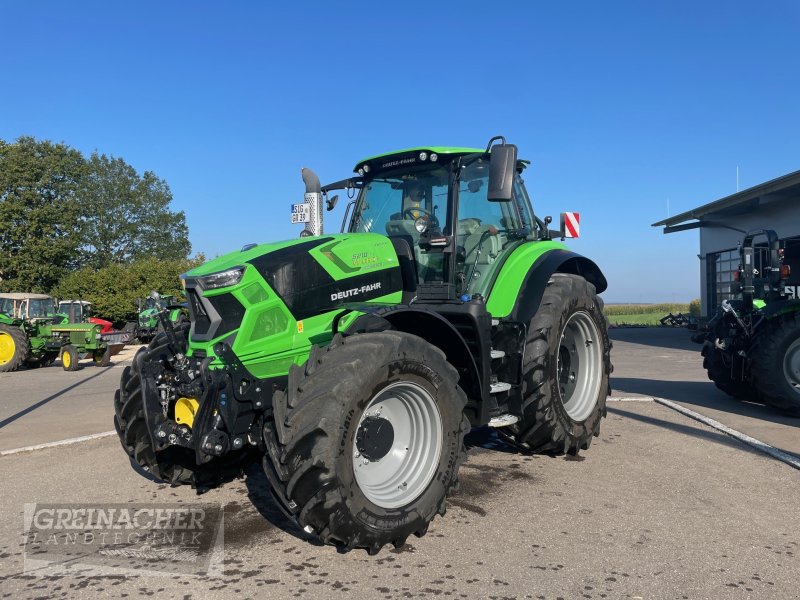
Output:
top-left (747, 313), bottom-right (800, 417)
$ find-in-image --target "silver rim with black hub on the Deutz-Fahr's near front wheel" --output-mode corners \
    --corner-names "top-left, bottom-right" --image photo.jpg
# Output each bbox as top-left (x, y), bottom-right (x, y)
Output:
top-left (352, 381), bottom-right (444, 508)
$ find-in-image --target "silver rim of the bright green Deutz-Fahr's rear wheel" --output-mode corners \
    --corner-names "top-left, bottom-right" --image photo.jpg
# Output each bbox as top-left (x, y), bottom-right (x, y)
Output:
top-left (557, 311), bottom-right (603, 421)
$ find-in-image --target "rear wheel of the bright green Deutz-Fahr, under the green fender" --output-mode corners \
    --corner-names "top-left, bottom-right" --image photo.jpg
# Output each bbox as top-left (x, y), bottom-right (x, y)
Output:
top-left (500, 273), bottom-right (611, 454)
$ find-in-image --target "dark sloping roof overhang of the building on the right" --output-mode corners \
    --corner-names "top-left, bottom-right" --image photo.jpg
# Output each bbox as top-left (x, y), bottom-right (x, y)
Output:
top-left (652, 171), bottom-right (800, 233)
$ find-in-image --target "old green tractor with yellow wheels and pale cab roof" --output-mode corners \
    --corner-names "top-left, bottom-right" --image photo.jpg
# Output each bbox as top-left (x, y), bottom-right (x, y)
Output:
top-left (0, 293), bottom-right (111, 373)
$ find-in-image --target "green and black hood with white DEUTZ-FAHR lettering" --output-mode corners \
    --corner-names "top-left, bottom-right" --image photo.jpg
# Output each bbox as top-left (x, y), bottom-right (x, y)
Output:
top-left (184, 233), bottom-right (403, 356)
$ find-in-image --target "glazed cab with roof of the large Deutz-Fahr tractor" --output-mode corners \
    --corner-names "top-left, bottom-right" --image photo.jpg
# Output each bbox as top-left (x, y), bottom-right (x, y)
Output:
top-left (347, 140), bottom-right (544, 300)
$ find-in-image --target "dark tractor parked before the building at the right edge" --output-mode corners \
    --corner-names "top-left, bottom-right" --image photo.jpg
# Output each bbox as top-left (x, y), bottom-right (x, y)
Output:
top-left (693, 229), bottom-right (800, 417)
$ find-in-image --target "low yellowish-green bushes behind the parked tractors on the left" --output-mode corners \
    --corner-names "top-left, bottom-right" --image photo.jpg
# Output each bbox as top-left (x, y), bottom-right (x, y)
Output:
top-left (52, 255), bottom-right (205, 326)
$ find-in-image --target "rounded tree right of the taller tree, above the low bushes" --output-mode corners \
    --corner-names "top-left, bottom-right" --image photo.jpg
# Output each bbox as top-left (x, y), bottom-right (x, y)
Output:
top-left (80, 152), bottom-right (191, 268)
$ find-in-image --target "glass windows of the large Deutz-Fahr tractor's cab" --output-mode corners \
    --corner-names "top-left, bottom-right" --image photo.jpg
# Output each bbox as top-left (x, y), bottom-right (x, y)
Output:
top-left (349, 154), bottom-right (537, 297)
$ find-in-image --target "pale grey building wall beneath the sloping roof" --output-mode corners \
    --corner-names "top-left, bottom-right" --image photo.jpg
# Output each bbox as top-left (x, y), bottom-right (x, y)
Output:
top-left (700, 197), bottom-right (800, 315)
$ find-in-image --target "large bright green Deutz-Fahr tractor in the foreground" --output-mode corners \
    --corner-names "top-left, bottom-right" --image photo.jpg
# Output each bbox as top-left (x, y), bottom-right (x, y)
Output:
top-left (114, 138), bottom-right (611, 554)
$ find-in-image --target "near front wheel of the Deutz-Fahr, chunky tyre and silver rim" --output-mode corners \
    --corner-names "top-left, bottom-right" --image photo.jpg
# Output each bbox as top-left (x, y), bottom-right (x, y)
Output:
top-left (264, 331), bottom-right (469, 554)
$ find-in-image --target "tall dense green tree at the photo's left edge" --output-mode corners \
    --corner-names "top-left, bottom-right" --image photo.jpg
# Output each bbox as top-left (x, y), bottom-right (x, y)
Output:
top-left (0, 137), bottom-right (86, 292)
